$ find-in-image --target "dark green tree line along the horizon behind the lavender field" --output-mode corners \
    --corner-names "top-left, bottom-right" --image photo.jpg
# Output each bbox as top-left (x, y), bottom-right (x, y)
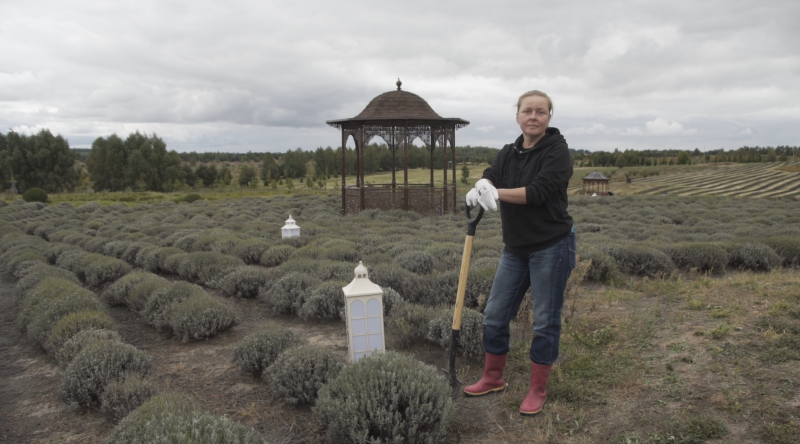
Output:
top-left (6, 125), bottom-right (797, 193)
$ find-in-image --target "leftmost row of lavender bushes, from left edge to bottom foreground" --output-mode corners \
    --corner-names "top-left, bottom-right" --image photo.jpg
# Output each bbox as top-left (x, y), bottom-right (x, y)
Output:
top-left (0, 223), bottom-right (266, 444)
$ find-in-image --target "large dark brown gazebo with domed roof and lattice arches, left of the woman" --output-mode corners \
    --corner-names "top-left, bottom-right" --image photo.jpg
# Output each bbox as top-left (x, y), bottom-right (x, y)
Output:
top-left (326, 79), bottom-right (469, 219)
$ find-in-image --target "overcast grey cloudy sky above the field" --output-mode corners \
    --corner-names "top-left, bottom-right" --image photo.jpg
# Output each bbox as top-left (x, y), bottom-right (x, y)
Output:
top-left (0, 0), bottom-right (800, 152)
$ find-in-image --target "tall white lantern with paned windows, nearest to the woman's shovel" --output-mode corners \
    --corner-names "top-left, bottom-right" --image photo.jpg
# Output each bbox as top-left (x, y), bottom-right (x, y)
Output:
top-left (342, 261), bottom-right (386, 362)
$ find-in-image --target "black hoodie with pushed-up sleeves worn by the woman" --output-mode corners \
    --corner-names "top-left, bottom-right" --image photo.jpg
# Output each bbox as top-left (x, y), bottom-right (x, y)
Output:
top-left (483, 128), bottom-right (572, 254)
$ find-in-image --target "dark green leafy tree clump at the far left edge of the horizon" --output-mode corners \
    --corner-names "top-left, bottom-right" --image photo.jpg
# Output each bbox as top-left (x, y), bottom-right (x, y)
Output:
top-left (0, 130), bottom-right (78, 193)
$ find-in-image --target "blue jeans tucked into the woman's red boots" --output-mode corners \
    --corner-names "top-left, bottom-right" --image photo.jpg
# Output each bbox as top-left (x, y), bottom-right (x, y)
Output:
top-left (483, 233), bottom-right (575, 365)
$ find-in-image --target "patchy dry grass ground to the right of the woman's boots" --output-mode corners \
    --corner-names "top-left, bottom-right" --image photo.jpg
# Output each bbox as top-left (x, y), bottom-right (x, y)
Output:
top-left (524, 270), bottom-right (800, 444)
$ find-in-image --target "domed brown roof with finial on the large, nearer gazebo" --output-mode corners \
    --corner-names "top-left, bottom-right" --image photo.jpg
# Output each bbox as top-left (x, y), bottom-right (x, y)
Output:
top-left (325, 79), bottom-right (469, 128)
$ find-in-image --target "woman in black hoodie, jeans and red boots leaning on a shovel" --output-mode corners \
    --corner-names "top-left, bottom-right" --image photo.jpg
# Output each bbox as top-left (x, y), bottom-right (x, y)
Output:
top-left (464, 91), bottom-right (575, 416)
